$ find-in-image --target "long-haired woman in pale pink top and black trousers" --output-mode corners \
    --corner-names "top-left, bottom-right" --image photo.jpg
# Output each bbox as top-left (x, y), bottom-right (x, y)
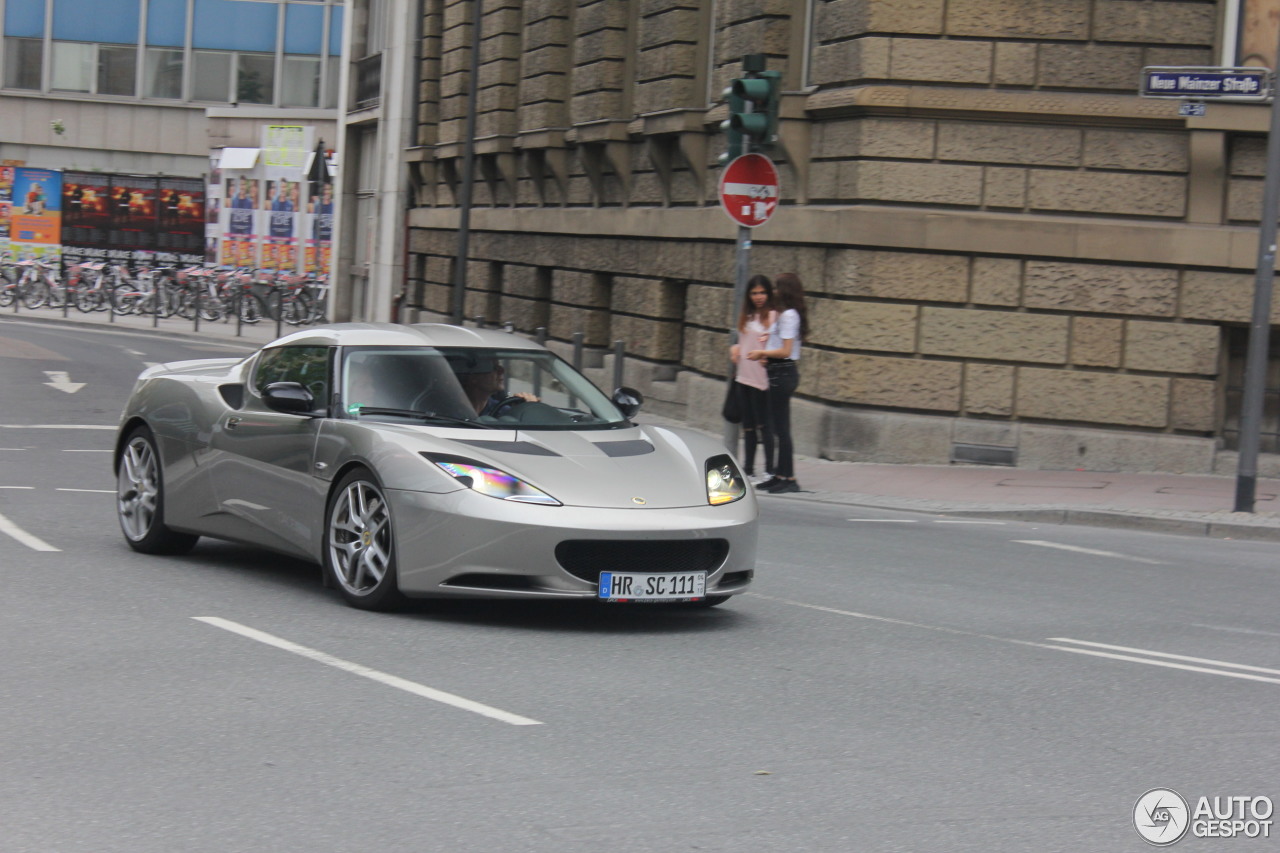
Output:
top-left (730, 275), bottom-right (778, 478)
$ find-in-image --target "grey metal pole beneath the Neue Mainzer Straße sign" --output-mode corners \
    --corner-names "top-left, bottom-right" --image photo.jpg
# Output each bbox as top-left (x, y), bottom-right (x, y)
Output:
top-left (1235, 58), bottom-right (1280, 512)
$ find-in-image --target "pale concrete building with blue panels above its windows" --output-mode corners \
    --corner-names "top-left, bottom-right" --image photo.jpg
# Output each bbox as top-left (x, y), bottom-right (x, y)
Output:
top-left (0, 0), bottom-right (344, 188)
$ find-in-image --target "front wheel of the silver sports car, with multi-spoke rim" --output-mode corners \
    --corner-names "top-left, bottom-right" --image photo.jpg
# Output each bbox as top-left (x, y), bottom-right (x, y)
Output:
top-left (324, 467), bottom-right (406, 610)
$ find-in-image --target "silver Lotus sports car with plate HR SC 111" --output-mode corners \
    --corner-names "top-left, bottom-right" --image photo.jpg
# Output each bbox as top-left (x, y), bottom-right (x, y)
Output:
top-left (114, 323), bottom-right (758, 610)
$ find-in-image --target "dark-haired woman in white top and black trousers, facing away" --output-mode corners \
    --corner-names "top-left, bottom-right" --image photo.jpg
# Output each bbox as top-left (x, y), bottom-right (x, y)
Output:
top-left (746, 273), bottom-right (809, 494)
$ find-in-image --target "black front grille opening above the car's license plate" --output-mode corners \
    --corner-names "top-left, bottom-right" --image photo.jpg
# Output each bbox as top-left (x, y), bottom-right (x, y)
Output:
top-left (556, 539), bottom-right (728, 583)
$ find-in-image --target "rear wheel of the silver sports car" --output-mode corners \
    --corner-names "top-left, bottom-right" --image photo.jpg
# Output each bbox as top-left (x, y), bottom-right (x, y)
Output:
top-left (115, 427), bottom-right (200, 553)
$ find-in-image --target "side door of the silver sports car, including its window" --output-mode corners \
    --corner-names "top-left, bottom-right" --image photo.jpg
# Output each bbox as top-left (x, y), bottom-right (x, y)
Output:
top-left (210, 346), bottom-right (333, 560)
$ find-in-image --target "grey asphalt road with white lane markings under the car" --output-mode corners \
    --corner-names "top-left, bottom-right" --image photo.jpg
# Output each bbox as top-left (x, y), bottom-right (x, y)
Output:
top-left (0, 320), bottom-right (1280, 853)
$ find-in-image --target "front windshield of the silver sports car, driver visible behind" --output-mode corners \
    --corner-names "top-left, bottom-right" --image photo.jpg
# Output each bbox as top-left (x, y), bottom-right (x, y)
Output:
top-left (342, 347), bottom-right (627, 429)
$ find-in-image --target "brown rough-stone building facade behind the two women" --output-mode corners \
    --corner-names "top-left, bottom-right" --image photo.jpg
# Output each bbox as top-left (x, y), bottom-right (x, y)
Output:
top-left (391, 0), bottom-right (1280, 473)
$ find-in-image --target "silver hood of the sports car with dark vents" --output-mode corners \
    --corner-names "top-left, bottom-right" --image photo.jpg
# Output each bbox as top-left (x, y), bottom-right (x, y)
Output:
top-left (404, 417), bottom-right (726, 508)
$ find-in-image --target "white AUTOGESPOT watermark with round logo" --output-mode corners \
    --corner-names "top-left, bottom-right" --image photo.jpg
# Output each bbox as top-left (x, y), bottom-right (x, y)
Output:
top-left (1133, 788), bottom-right (1275, 847)
